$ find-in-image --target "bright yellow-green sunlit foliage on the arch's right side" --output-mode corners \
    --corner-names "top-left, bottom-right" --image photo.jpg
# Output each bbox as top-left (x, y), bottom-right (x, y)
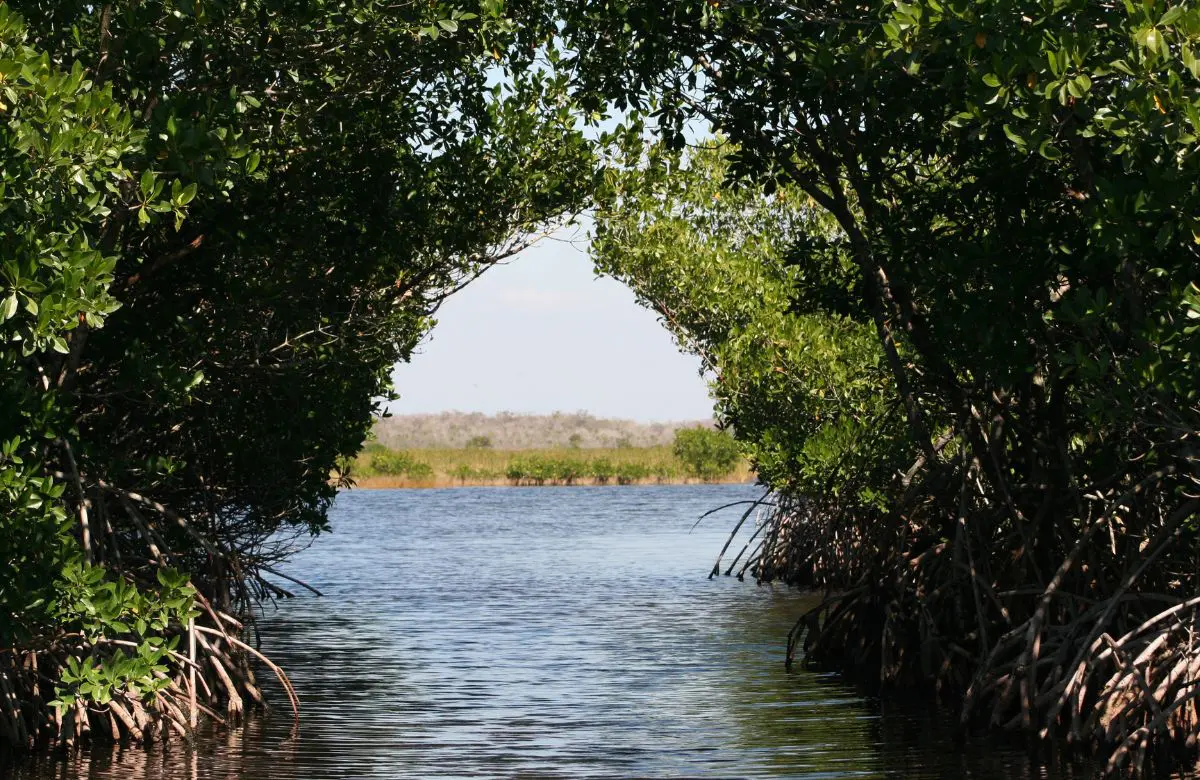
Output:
top-left (593, 144), bottom-right (896, 488)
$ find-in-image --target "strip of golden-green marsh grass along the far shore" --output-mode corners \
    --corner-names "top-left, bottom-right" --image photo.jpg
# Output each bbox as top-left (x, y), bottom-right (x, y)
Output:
top-left (350, 443), bottom-right (754, 487)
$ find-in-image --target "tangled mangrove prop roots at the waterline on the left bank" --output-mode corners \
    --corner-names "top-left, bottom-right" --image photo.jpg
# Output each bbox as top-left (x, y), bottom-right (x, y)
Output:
top-left (0, 443), bottom-right (319, 752)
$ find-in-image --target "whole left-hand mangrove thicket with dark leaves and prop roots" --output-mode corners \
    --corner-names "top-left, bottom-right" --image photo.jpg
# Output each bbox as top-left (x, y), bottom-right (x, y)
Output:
top-left (0, 0), bottom-right (593, 754)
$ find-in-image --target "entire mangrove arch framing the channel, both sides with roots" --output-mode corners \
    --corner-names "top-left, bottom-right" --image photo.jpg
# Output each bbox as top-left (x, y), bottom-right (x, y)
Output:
top-left (0, 0), bottom-right (1200, 770)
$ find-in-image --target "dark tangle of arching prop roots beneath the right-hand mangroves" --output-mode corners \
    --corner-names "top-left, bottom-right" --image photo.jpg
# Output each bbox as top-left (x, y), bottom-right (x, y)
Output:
top-left (722, 444), bottom-right (1200, 775)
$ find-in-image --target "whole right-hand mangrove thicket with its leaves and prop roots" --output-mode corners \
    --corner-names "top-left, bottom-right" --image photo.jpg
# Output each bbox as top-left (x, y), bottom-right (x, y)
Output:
top-left (564, 0), bottom-right (1200, 775)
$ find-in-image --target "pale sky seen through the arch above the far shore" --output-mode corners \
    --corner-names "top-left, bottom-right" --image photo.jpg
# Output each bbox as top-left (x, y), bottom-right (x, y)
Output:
top-left (390, 224), bottom-right (713, 422)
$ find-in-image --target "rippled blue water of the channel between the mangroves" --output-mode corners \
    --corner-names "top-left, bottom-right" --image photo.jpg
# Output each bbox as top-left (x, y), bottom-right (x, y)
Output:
top-left (0, 486), bottom-right (1104, 780)
